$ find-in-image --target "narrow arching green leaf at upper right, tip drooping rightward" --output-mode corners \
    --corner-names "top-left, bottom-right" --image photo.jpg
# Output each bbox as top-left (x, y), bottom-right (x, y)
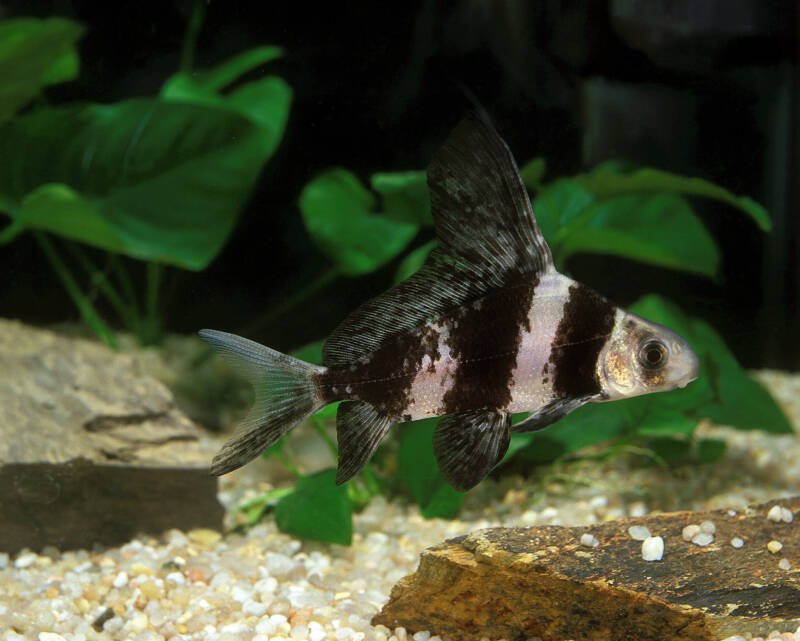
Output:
top-left (573, 166), bottom-right (771, 231)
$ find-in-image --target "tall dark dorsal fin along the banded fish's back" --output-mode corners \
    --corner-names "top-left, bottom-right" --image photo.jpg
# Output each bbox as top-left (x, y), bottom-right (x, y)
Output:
top-left (323, 113), bottom-right (554, 366)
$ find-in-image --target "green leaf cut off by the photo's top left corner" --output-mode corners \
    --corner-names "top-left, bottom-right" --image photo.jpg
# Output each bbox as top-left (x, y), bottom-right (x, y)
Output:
top-left (0, 18), bottom-right (83, 123)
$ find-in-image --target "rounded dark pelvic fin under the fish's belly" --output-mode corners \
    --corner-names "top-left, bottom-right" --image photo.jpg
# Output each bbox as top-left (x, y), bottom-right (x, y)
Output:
top-left (433, 410), bottom-right (511, 492)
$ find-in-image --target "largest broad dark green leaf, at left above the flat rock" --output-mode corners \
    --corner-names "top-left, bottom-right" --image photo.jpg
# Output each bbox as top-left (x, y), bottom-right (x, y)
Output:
top-left (0, 99), bottom-right (268, 269)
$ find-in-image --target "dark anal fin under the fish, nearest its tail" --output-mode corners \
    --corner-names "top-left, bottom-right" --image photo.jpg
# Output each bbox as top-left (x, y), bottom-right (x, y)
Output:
top-left (336, 401), bottom-right (395, 485)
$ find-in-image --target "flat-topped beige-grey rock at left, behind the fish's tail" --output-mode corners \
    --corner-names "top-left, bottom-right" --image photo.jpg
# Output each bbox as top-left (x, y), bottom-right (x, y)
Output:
top-left (0, 319), bottom-right (223, 553)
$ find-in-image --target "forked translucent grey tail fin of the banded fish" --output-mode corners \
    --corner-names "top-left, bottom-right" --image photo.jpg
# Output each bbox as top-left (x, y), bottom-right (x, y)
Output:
top-left (199, 329), bottom-right (326, 476)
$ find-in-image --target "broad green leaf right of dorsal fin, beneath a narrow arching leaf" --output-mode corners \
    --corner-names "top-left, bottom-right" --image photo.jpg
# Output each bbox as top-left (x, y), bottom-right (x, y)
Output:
top-left (554, 194), bottom-right (719, 276)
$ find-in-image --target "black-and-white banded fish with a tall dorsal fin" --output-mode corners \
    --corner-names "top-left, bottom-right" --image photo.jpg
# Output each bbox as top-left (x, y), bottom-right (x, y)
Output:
top-left (199, 111), bottom-right (700, 491)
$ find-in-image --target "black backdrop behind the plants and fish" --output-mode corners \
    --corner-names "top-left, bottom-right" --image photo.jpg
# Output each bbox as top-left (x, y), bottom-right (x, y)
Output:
top-left (0, 0), bottom-right (800, 370)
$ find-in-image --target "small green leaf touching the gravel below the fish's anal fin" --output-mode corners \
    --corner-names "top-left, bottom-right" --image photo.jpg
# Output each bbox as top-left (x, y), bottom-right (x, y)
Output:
top-left (275, 468), bottom-right (353, 545)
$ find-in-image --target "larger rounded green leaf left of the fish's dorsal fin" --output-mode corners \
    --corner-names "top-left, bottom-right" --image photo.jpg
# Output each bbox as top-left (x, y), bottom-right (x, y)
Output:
top-left (300, 169), bottom-right (419, 276)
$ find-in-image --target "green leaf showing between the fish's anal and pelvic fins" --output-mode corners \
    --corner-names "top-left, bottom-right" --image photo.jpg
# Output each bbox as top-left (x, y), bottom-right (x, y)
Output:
top-left (398, 419), bottom-right (465, 519)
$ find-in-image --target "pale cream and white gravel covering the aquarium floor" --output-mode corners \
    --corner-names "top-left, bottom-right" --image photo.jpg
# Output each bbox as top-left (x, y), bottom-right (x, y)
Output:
top-left (0, 372), bottom-right (800, 641)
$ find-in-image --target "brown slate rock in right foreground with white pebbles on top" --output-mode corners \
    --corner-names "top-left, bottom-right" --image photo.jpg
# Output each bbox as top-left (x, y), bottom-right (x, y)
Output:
top-left (372, 497), bottom-right (800, 641)
